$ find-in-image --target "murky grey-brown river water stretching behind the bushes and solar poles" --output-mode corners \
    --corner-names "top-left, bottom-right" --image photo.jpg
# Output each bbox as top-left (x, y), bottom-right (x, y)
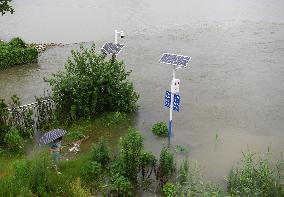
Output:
top-left (0, 0), bottom-right (284, 186)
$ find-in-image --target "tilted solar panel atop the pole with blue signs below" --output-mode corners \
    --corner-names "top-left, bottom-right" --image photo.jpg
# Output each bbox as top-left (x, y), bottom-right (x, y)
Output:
top-left (159, 53), bottom-right (191, 67)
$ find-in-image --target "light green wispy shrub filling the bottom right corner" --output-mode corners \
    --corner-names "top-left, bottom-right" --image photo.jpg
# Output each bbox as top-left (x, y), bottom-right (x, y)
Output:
top-left (228, 152), bottom-right (284, 196)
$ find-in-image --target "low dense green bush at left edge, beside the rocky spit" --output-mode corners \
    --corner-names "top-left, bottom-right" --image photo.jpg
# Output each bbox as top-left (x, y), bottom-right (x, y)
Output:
top-left (0, 38), bottom-right (38, 68)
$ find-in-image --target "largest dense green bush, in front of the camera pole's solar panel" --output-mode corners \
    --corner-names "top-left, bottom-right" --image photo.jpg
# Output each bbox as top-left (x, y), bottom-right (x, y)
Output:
top-left (47, 45), bottom-right (138, 121)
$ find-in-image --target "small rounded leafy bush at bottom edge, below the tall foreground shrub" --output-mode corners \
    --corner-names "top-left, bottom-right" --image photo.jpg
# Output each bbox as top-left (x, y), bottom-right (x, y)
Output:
top-left (110, 174), bottom-right (132, 197)
